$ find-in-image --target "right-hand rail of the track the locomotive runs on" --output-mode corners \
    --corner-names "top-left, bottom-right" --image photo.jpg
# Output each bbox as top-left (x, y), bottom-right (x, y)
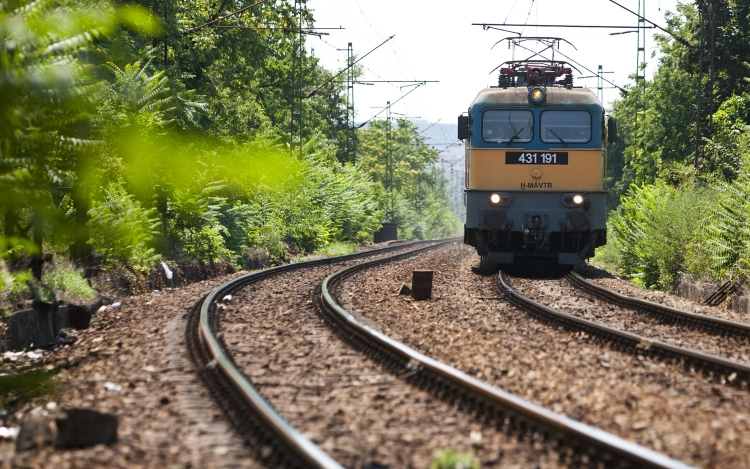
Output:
top-left (565, 272), bottom-right (750, 337)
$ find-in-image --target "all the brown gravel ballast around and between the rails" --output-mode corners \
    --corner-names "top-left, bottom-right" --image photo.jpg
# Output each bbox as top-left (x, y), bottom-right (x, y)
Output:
top-left (10, 243), bottom-right (750, 468)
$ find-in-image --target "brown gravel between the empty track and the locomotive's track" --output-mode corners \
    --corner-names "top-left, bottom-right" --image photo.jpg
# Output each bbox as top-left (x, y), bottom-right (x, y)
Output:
top-left (341, 246), bottom-right (750, 468)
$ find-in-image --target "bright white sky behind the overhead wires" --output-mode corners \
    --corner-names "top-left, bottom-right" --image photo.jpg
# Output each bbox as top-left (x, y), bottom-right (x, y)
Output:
top-left (305, 0), bottom-right (680, 123)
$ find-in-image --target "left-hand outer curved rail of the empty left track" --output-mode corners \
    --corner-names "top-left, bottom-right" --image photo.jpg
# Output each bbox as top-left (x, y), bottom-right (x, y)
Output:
top-left (198, 241), bottom-right (446, 469)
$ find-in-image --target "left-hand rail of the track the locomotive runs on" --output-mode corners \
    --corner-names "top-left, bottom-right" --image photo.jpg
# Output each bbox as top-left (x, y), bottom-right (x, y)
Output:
top-left (498, 272), bottom-right (750, 386)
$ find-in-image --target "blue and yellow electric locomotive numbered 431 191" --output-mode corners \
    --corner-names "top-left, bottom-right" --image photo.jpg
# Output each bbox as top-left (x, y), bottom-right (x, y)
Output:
top-left (458, 38), bottom-right (616, 266)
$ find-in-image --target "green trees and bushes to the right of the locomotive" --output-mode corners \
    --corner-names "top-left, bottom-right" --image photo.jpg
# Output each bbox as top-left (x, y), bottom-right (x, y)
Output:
top-left (598, 0), bottom-right (750, 290)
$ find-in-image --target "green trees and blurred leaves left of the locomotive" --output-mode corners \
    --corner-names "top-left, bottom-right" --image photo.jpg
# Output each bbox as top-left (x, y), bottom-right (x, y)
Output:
top-left (0, 0), bottom-right (457, 299)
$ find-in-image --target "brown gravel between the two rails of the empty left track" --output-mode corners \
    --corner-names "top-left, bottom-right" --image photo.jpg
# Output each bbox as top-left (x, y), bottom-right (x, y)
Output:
top-left (222, 246), bottom-right (564, 468)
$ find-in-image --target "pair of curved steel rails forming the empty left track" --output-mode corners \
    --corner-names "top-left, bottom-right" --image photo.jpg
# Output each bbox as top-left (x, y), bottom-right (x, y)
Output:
top-left (187, 241), bottom-right (700, 468)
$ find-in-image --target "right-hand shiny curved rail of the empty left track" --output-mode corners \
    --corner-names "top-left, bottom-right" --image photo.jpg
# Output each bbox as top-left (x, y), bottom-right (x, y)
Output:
top-left (321, 250), bottom-right (692, 469)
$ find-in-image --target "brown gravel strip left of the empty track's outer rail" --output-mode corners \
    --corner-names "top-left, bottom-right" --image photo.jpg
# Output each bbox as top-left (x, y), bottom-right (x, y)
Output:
top-left (5, 270), bottom-right (260, 468)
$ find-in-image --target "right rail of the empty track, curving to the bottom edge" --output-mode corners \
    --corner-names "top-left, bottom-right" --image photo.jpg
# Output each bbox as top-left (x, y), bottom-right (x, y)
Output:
top-left (321, 249), bottom-right (689, 468)
